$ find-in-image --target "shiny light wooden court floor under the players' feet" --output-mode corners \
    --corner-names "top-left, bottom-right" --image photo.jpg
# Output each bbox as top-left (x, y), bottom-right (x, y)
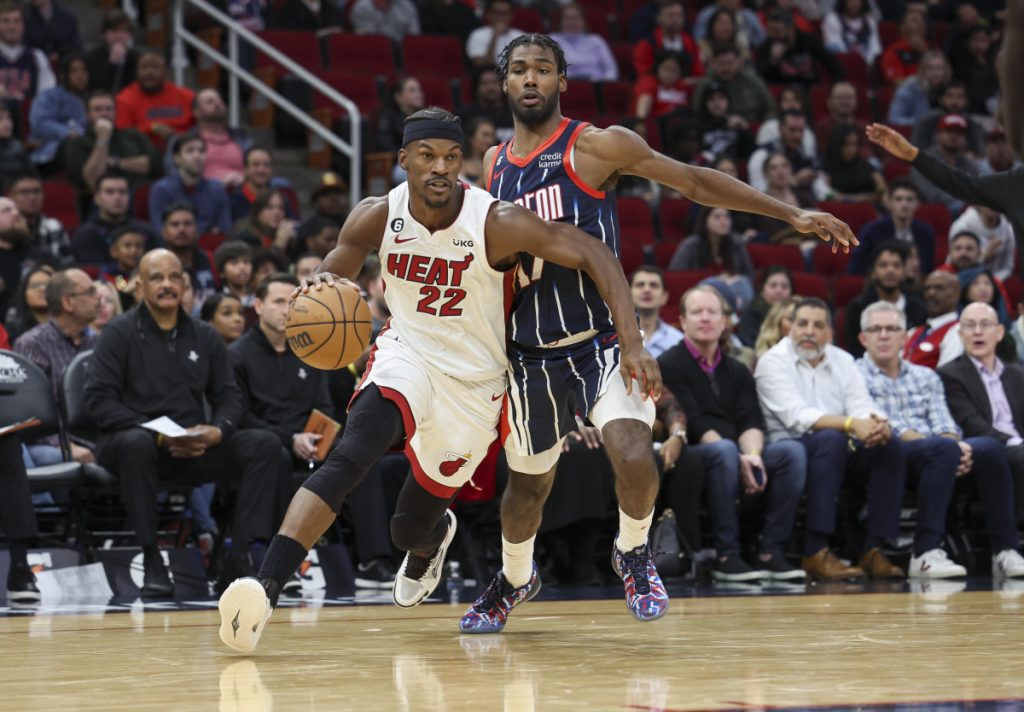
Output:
top-left (0, 591), bottom-right (1024, 712)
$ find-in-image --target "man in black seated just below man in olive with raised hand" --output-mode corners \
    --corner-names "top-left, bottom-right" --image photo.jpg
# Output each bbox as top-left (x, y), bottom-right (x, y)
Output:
top-left (71, 173), bottom-right (160, 264)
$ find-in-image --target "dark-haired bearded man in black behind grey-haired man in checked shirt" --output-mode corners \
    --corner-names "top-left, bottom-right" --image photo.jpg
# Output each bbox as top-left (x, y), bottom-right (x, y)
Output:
top-left (844, 240), bottom-right (928, 359)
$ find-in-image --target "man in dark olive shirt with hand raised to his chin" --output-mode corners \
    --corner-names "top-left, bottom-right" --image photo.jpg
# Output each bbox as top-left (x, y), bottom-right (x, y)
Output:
top-left (56, 90), bottom-right (163, 195)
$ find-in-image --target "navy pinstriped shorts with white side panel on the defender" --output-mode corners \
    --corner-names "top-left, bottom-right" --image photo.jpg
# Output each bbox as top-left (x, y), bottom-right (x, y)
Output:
top-left (502, 332), bottom-right (654, 474)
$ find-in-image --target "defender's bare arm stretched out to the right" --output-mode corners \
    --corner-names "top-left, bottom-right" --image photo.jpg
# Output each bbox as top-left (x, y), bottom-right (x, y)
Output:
top-left (575, 126), bottom-right (859, 252)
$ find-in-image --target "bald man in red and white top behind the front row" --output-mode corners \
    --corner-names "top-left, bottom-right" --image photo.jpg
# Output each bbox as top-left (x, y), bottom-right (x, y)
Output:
top-left (903, 270), bottom-right (964, 370)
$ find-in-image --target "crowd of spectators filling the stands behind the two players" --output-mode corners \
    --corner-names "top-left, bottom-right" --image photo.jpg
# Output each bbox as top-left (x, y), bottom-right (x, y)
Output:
top-left (0, 0), bottom-right (1024, 594)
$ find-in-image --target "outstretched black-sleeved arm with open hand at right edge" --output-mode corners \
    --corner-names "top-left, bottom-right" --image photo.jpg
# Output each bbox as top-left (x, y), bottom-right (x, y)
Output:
top-left (867, 122), bottom-right (1024, 278)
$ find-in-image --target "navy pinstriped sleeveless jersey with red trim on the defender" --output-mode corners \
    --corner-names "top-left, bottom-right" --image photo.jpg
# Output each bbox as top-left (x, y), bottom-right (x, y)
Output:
top-left (487, 119), bottom-right (620, 346)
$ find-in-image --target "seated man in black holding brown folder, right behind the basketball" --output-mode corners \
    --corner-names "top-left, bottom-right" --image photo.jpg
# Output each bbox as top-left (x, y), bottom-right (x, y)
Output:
top-left (227, 273), bottom-right (409, 588)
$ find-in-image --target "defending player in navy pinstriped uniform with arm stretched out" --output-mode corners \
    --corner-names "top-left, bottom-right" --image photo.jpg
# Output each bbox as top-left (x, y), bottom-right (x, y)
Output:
top-left (460, 34), bottom-right (857, 633)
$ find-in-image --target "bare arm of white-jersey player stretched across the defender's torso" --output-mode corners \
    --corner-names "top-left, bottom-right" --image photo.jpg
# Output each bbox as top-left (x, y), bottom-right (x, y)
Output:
top-left (486, 202), bottom-right (662, 399)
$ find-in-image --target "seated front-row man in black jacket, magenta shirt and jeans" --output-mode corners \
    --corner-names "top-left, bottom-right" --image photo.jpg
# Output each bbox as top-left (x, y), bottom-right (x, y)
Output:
top-left (657, 286), bottom-right (807, 581)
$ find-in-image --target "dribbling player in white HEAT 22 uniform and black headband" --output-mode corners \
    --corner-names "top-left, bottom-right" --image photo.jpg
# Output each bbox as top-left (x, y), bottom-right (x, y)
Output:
top-left (219, 109), bottom-right (660, 653)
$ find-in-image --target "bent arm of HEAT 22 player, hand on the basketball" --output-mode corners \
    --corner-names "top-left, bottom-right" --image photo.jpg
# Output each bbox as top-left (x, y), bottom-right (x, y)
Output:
top-left (295, 196), bottom-right (387, 294)
